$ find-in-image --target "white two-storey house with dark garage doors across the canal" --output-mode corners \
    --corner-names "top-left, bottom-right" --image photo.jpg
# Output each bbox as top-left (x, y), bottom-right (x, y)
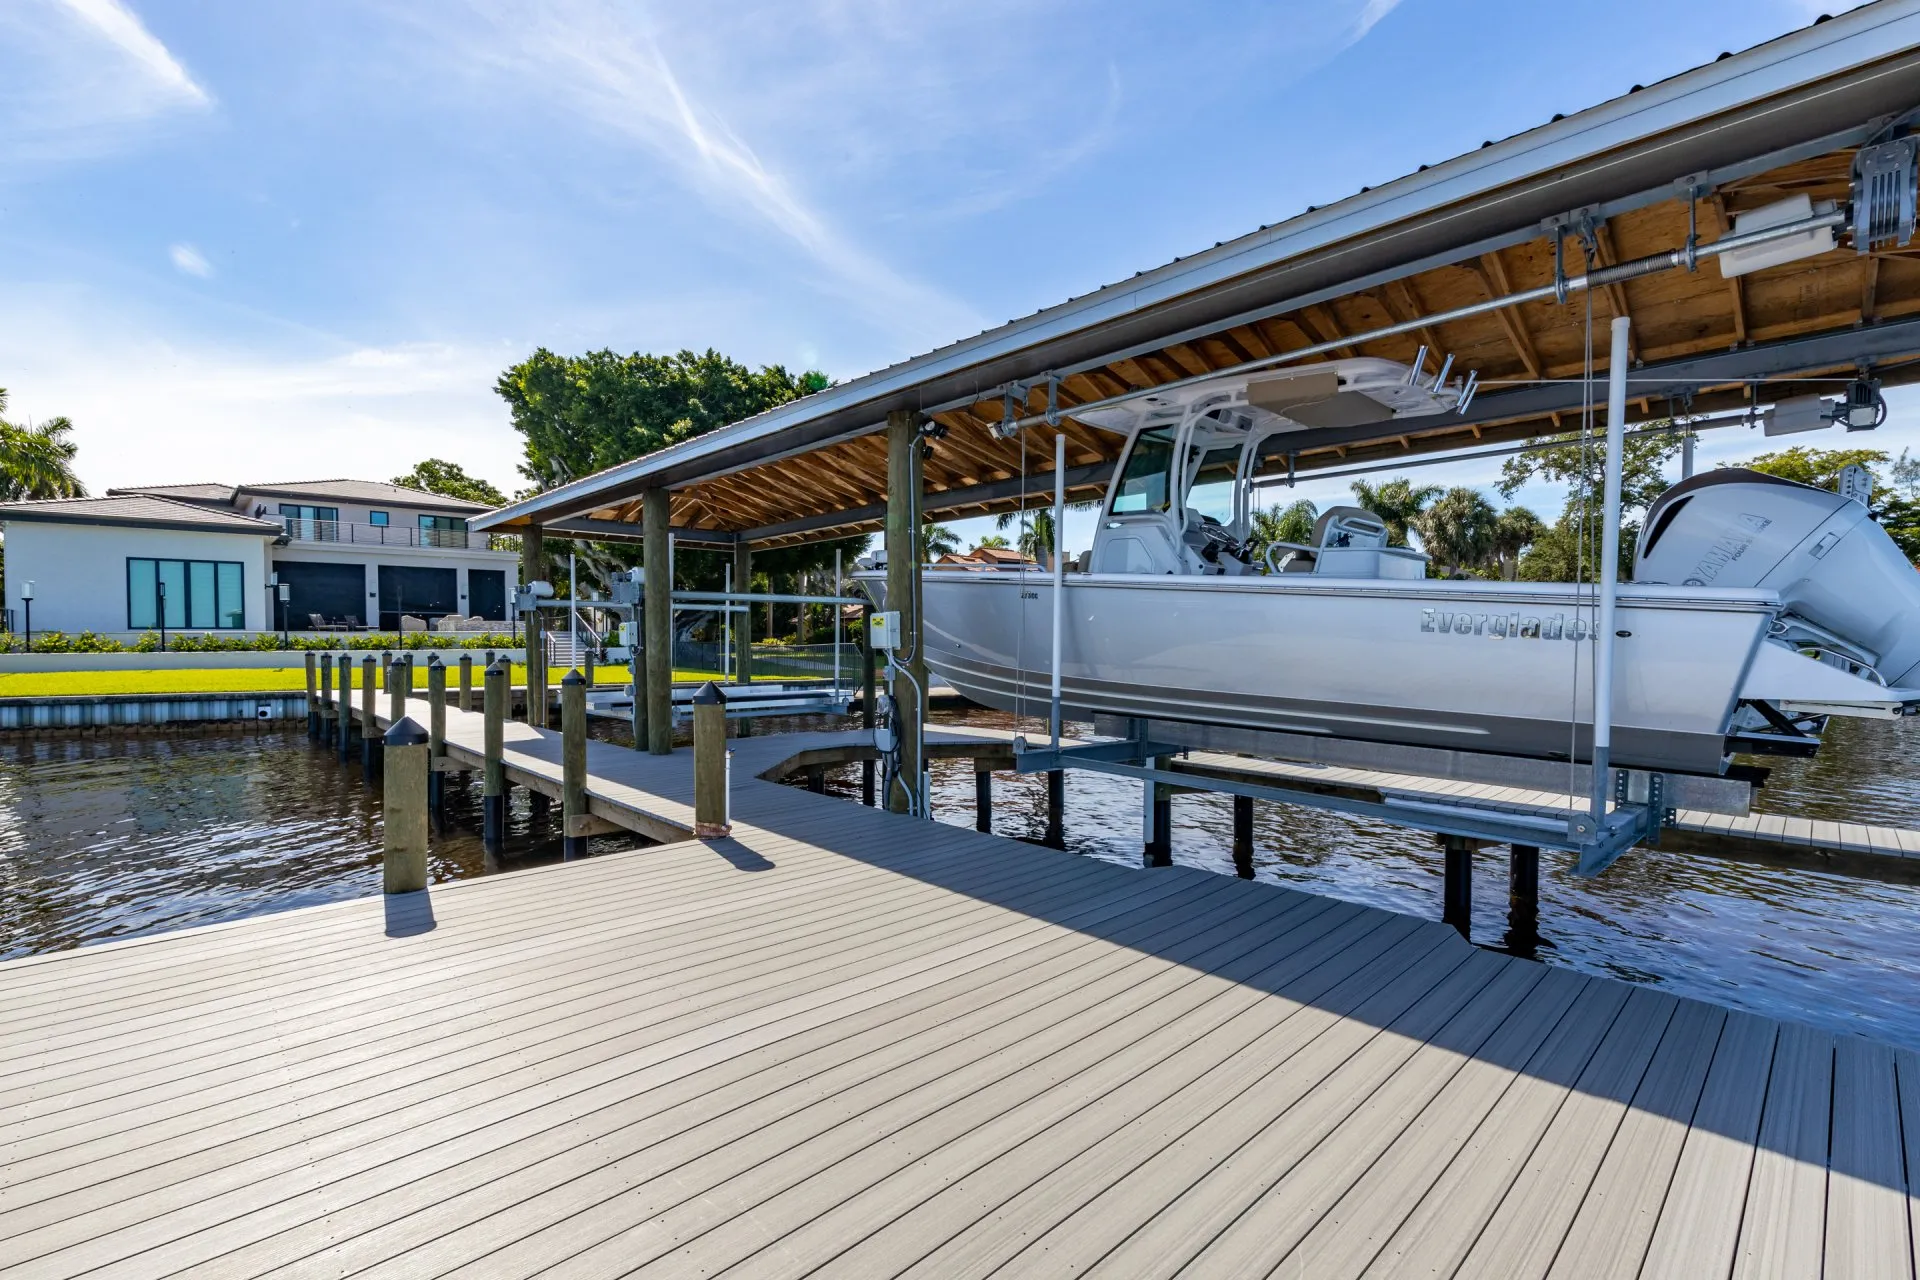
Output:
top-left (0, 480), bottom-right (518, 637)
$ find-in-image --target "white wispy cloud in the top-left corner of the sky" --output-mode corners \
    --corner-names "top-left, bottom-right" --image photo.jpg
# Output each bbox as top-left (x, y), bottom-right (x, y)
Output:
top-left (0, 0), bottom-right (213, 159)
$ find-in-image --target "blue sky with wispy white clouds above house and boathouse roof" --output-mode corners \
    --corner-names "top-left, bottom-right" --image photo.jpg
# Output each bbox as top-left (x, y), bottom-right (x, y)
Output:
top-left (0, 0), bottom-right (1920, 545)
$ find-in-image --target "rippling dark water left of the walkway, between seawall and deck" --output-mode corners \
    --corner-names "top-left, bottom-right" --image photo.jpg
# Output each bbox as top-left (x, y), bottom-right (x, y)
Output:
top-left (0, 729), bottom-right (639, 958)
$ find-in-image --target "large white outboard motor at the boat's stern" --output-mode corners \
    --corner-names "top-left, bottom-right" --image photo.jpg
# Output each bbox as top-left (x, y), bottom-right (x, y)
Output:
top-left (1634, 466), bottom-right (1920, 689)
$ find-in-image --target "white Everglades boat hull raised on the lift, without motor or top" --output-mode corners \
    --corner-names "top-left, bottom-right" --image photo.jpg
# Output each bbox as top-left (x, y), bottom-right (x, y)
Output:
top-left (862, 570), bottom-right (1778, 773)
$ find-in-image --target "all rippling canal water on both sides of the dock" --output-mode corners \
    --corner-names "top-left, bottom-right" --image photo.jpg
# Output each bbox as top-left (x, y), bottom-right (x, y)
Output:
top-left (0, 712), bottom-right (1920, 1048)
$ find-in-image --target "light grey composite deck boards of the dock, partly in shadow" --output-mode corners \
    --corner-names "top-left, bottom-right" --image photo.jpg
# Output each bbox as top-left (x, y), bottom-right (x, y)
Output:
top-left (0, 712), bottom-right (1920, 1280)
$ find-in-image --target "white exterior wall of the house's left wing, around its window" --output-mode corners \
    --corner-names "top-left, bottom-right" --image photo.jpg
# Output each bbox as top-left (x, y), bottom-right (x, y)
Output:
top-left (6, 520), bottom-right (274, 633)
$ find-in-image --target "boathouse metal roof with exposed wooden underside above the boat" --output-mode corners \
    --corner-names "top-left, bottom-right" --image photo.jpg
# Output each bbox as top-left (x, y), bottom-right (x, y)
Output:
top-left (474, 0), bottom-right (1920, 545)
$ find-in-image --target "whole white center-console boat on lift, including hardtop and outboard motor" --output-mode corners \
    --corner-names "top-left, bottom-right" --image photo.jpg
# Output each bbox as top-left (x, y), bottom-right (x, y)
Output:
top-left (860, 359), bottom-right (1920, 775)
